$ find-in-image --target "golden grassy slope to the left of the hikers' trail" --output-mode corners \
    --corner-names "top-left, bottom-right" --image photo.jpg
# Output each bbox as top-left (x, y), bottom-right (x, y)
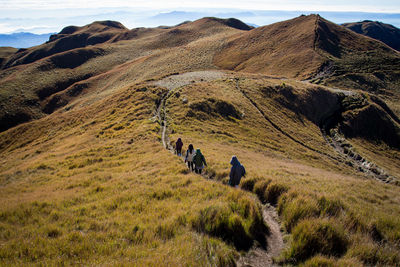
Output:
top-left (0, 83), bottom-right (268, 265)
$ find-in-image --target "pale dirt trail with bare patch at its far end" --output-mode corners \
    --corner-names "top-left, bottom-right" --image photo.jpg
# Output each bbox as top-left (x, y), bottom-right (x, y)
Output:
top-left (154, 71), bottom-right (284, 267)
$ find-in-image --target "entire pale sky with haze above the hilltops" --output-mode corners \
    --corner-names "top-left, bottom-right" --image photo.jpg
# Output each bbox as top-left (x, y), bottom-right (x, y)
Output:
top-left (0, 0), bottom-right (400, 34)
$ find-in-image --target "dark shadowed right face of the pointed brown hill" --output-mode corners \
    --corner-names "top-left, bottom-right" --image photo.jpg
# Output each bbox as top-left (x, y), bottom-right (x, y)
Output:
top-left (315, 17), bottom-right (400, 97)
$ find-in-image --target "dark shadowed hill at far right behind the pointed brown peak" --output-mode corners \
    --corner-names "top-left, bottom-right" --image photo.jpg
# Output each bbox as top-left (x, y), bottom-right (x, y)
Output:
top-left (342, 20), bottom-right (400, 51)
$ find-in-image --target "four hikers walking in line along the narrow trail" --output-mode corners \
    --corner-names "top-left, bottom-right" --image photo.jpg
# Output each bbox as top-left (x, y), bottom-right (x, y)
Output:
top-left (175, 138), bottom-right (246, 187)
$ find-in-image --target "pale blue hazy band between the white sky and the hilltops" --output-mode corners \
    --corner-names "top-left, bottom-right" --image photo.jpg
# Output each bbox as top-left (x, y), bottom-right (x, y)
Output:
top-left (0, 7), bottom-right (400, 34)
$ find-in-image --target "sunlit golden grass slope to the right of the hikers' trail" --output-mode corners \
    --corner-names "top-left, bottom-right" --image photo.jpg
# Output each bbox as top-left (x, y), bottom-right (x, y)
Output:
top-left (169, 79), bottom-right (400, 265)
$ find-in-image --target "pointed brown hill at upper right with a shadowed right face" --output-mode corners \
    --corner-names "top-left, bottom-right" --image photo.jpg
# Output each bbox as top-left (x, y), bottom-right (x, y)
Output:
top-left (214, 15), bottom-right (400, 97)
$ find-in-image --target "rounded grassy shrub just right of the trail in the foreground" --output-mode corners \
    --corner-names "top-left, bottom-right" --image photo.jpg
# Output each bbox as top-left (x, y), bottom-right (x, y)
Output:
top-left (286, 219), bottom-right (348, 262)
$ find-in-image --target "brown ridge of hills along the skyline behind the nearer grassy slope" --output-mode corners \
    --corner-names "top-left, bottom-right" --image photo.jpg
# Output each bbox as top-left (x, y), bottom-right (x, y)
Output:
top-left (1, 15), bottom-right (399, 133)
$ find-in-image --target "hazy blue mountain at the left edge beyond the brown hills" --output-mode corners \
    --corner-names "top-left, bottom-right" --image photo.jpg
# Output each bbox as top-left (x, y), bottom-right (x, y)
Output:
top-left (0, 32), bottom-right (53, 48)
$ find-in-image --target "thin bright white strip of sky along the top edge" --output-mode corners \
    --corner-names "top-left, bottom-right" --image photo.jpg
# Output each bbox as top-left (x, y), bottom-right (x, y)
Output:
top-left (0, 0), bottom-right (400, 12)
